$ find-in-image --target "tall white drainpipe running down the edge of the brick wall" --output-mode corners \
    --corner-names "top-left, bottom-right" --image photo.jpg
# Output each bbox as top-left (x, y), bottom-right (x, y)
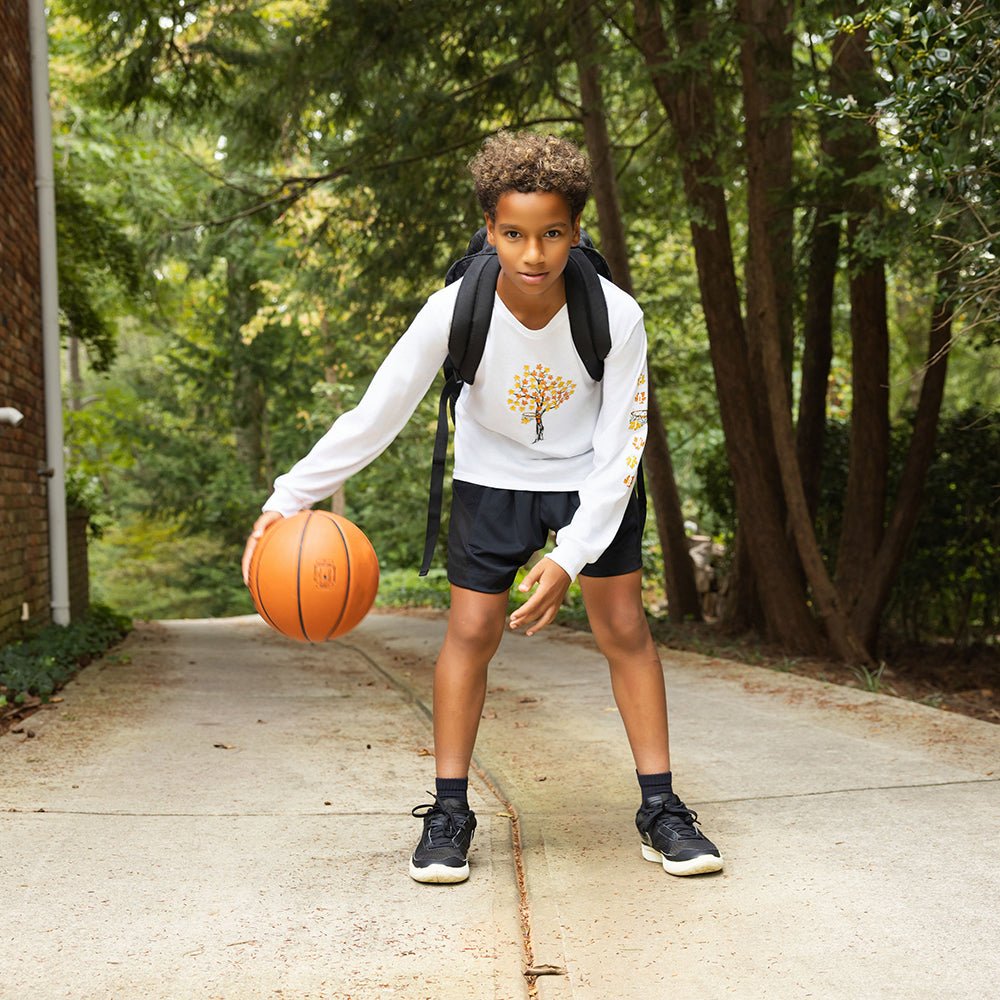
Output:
top-left (28, 0), bottom-right (69, 625)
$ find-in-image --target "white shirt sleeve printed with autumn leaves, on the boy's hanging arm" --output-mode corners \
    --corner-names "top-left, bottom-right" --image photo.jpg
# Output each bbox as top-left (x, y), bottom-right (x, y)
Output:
top-left (549, 316), bottom-right (649, 579)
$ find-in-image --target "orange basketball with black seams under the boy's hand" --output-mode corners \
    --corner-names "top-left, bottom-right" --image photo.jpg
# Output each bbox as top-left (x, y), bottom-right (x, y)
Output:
top-left (249, 510), bottom-right (378, 642)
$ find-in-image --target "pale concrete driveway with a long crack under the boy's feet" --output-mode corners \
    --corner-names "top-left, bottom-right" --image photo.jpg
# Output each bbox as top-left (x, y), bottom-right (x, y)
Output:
top-left (0, 614), bottom-right (1000, 1000)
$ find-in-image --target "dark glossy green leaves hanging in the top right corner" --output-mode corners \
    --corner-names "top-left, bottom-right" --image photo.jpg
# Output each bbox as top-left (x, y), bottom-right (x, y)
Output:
top-left (803, 0), bottom-right (1000, 345)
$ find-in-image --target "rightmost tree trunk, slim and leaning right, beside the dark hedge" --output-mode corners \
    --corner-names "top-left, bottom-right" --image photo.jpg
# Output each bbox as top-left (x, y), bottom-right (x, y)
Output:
top-left (851, 284), bottom-right (952, 650)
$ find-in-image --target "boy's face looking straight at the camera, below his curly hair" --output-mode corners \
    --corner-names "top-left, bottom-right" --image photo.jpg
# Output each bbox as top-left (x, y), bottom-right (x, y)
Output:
top-left (486, 191), bottom-right (580, 304)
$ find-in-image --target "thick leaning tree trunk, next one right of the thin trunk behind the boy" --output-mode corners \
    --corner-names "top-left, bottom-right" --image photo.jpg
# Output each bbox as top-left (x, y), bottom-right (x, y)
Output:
top-left (635, 0), bottom-right (819, 650)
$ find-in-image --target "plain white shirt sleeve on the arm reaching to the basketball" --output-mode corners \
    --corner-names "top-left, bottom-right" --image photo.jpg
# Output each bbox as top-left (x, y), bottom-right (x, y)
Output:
top-left (263, 290), bottom-right (453, 517)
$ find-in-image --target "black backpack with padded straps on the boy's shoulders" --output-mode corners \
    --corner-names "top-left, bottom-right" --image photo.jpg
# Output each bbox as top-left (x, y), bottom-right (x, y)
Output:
top-left (420, 226), bottom-right (644, 576)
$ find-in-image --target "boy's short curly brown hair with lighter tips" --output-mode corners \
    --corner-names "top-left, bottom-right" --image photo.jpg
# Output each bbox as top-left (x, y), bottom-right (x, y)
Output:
top-left (469, 131), bottom-right (591, 219)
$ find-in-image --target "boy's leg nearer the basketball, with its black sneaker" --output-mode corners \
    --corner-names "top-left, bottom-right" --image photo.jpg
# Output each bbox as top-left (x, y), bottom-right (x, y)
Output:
top-left (410, 585), bottom-right (507, 882)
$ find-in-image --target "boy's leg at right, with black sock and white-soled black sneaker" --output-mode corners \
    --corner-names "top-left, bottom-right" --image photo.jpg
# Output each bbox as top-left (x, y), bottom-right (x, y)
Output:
top-left (579, 570), bottom-right (722, 875)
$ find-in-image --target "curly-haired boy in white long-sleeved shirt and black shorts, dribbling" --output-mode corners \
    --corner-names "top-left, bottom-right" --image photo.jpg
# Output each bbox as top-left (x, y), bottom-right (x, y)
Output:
top-left (243, 132), bottom-right (722, 883)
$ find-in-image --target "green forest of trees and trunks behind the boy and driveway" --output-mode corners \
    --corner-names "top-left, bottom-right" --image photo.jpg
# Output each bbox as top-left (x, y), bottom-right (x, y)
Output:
top-left (49, 0), bottom-right (1000, 700)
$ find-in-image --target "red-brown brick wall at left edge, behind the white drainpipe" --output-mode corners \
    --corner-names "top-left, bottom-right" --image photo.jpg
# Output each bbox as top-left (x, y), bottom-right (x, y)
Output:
top-left (0, 0), bottom-right (50, 644)
